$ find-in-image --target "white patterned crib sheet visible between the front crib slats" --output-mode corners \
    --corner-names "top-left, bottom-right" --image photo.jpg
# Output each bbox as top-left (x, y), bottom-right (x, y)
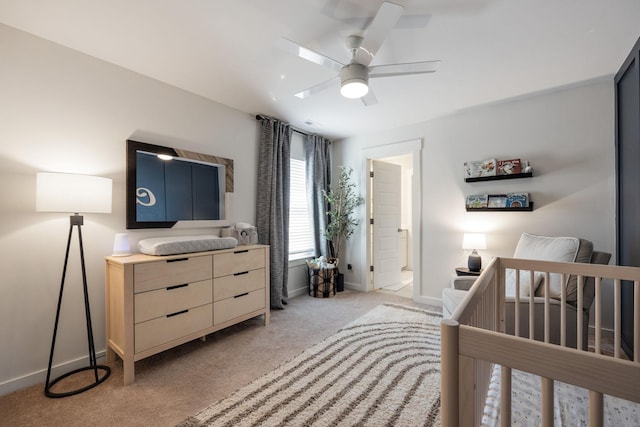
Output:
top-left (482, 365), bottom-right (640, 426)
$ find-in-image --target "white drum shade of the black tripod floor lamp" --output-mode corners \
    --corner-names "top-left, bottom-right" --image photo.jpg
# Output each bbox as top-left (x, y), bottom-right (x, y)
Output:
top-left (36, 172), bottom-right (112, 213)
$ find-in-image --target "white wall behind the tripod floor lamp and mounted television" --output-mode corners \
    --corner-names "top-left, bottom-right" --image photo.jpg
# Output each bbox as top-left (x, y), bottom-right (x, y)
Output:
top-left (0, 25), bottom-right (258, 395)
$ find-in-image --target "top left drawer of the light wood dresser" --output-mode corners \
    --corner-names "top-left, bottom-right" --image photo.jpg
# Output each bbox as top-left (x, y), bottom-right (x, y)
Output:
top-left (133, 255), bottom-right (213, 293)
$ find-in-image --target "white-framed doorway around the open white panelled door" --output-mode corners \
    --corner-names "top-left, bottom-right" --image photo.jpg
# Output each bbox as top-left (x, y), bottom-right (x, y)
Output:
top-left (363, 140), bottom-right (422, 301)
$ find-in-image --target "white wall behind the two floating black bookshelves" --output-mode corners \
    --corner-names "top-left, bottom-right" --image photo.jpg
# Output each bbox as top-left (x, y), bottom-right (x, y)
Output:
top-left (334, 78), bottom-right (615, 325)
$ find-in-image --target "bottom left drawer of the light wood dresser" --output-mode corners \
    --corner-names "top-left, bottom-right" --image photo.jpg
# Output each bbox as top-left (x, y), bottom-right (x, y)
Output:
top-left (134, 304), bottom-right (212, 353)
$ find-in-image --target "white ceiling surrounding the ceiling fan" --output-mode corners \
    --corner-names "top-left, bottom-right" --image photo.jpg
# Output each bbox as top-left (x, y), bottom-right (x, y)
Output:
top-left (0, 0), bottom-right (640, 138)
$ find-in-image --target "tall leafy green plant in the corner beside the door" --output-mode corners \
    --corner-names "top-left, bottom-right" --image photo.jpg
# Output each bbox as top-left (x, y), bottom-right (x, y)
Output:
top-left (322, 166), bottom-right (364, 291)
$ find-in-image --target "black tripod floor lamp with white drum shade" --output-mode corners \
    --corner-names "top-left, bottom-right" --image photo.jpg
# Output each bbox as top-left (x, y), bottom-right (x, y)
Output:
top-left (36, 172), bottom-right (111, 397)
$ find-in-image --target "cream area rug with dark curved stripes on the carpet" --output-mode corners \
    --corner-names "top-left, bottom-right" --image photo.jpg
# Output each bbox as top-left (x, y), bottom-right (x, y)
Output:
top-left (179, 304), bottom-right (441, 427)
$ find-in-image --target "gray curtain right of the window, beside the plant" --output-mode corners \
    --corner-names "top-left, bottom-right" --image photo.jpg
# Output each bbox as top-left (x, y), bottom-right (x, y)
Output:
top-left (304, 135), bottom-right (331, 257)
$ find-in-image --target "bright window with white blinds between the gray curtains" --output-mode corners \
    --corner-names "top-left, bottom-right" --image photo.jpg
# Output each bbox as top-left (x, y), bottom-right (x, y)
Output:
top-left (289, 134), bottom-right (313, 260)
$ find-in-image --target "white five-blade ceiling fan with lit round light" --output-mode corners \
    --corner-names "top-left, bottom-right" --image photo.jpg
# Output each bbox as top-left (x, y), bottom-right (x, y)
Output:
top-left (282, 2), bottom-right (440, 105)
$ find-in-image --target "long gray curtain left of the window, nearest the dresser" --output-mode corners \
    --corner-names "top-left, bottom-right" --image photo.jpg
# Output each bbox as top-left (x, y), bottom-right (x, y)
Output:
top-left (256, 116), bottom-right (292, 309)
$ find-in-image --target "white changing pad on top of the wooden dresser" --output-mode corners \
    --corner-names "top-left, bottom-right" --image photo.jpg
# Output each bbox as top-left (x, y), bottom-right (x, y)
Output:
top-left (138, 235), bottom-right (238, 255)
